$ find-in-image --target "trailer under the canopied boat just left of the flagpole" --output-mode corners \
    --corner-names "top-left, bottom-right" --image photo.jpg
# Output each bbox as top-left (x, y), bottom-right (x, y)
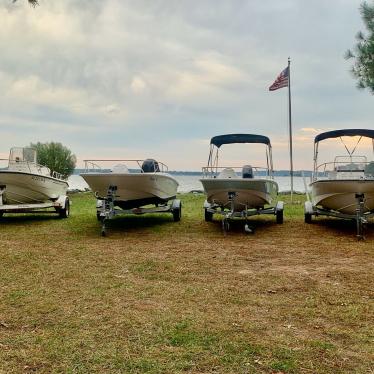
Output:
top-left (204, 192), bottom-right (284, 235)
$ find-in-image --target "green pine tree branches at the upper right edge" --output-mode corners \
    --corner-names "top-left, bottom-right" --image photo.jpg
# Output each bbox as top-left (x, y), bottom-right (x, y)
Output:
top-left (345, 1), bottom-right (374, 94)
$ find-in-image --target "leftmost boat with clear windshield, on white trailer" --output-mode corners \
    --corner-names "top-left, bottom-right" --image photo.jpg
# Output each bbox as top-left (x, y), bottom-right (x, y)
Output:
top-left (0, 147), bottom-right (69, 217)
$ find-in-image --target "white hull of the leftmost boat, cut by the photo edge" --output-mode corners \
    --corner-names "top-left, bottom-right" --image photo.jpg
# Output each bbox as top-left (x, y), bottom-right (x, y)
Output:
top-left (0, 170), bottom-right (68, 204)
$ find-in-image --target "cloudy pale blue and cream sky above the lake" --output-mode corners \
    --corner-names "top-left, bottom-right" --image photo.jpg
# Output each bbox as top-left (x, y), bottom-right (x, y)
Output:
top-left (0, 0), bottom-right (374, 170)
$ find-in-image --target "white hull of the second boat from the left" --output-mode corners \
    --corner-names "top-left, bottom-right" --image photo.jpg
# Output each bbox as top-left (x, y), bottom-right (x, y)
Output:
top-left (81, 172), bottom-right (178, 206)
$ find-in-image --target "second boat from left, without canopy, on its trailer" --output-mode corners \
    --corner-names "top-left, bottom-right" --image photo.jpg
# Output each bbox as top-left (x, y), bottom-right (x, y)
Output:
top-left (80, 159), bottom-right (182, 236)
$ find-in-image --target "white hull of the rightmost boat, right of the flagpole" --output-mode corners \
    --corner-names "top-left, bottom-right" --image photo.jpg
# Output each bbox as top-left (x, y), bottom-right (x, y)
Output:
top-left (310, 179), bottom-right (374, 214)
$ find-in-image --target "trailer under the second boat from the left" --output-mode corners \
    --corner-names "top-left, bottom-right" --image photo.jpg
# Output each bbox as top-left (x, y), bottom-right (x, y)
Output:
top-left (96, 186), bottom-right (182, 236)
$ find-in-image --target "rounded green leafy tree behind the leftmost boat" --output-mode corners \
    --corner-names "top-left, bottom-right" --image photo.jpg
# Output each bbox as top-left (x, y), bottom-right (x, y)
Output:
top-left (30, 142), bottom-right (77, 177)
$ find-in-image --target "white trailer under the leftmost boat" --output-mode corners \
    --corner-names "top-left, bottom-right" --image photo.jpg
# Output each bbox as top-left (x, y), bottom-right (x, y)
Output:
top-left (0, 186), bottom-right (70, 218)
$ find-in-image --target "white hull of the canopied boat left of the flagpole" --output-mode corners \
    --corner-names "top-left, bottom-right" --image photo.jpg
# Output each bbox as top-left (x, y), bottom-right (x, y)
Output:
top-left (200, 178), bottom-right (278, 212)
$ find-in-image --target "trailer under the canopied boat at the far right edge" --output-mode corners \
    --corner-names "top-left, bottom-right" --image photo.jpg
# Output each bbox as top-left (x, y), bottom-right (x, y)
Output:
top-left (304, 193), bottom-right (374, 240)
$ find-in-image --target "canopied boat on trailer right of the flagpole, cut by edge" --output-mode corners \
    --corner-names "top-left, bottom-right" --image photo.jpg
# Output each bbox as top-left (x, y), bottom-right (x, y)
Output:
top-left (304, 129), bottom-right (374, 239)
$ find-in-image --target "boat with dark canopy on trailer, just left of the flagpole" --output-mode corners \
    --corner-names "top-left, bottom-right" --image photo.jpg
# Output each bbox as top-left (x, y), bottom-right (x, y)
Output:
top-left (200, 134), bottom-right (283, 232)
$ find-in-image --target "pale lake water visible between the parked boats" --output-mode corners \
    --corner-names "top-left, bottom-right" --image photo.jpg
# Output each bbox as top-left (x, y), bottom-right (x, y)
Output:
top-left (69, 175), bottom-right (310, 192)
